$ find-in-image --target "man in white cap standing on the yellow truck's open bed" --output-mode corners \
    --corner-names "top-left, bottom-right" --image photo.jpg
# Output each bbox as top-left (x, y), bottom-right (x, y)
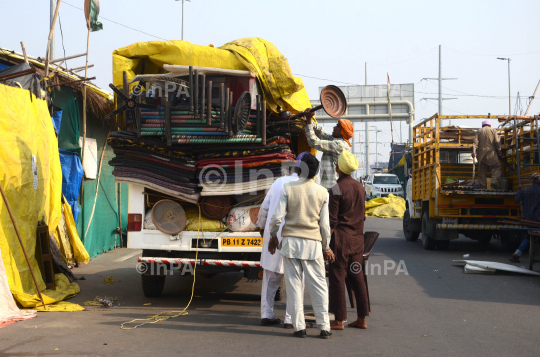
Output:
top-left (472, 120), bottom-right (502, 189)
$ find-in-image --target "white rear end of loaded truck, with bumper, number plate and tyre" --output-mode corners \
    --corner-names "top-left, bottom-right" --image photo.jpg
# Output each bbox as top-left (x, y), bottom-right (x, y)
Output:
top-left (127, 184), bottom-right (270, 300)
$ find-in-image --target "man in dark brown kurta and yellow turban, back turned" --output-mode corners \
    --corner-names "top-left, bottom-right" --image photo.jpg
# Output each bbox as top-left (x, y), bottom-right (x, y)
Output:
top-left (328, 151), bottom-right (369, 330)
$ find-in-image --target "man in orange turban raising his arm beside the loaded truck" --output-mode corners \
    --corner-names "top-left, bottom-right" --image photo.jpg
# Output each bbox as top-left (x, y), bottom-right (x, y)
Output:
top-left (303, 108), bottom-right (354, 190)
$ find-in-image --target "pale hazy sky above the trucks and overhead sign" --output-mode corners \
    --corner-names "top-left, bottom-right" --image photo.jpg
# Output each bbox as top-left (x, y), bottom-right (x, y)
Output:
top-left (0, 0), bottom-right (540, 170)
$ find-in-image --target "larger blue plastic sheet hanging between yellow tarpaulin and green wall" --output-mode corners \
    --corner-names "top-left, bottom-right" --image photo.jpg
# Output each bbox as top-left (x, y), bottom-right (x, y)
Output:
top-left (58, 149), bottom-right (83, 222)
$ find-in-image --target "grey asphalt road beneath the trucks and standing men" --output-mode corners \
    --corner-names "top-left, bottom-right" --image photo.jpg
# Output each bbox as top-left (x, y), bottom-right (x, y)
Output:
top-left (0, 218), bottom-right (540, 357)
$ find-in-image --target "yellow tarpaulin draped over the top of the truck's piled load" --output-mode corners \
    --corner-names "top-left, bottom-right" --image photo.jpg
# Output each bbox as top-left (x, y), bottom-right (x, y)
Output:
top-left (113, 37), bottom-right (316, 154)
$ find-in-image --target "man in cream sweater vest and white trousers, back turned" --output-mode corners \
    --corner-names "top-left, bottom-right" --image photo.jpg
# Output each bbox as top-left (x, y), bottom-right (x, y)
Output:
top-left (268, 154), bottom-right (333, 339)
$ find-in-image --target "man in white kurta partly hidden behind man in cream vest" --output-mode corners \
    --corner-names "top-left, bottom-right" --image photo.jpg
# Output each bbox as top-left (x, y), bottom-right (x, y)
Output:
top-left (257, 164), bottom-right (298, 328)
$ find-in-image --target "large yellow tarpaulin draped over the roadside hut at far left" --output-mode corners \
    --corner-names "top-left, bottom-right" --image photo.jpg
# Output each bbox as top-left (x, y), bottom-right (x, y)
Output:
top-left (0, 84), bottom-right (84, 308)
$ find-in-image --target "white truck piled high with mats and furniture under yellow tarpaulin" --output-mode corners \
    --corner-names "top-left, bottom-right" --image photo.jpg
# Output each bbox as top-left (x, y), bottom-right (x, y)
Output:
top-left (108, 38), bottom-right (344, 299)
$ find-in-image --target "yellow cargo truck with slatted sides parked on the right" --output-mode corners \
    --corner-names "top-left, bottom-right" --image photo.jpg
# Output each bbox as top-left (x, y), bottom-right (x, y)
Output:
top-left (403, 114), bottom-right (540, 250)
